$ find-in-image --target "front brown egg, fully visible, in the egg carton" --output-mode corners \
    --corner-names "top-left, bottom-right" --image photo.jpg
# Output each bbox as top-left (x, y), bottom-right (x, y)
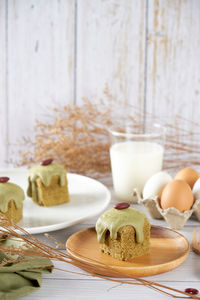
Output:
top-left (160, 180), bottom-right (194, 212)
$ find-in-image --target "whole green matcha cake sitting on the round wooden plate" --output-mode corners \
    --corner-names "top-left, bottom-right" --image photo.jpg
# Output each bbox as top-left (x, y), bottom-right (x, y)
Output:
top-left (96, 203), bottom-right (150, 260)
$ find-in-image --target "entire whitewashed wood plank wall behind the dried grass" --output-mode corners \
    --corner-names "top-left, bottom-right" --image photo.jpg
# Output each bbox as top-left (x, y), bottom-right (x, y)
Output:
top-left (0, 0), bottom-right (200, 167)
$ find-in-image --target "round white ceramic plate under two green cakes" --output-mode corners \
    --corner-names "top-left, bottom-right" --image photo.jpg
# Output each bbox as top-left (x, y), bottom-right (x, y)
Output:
top-left (0, 169), bottom-right (111, 234)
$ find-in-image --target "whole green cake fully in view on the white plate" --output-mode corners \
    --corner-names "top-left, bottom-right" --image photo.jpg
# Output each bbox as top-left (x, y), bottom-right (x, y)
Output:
top-left (27, 159), bottom-right (70, 206)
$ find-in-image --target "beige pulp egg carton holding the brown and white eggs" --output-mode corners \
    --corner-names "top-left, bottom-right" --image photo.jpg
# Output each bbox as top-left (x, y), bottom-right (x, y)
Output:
top-left (138, 195), bottom-right (200, 229)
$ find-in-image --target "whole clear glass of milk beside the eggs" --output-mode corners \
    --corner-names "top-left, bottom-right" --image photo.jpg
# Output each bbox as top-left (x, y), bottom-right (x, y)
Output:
top-left (109, 124), bottom-right (165, 202)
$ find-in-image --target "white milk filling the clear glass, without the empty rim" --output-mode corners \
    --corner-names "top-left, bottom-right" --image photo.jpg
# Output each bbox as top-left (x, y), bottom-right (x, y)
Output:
top-left (110, 141), bottom-right (164, 201)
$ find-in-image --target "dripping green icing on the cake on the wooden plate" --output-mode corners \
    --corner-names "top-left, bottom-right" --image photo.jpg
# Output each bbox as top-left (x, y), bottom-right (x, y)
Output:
top-left (96, 207), bottom-right (146, 243)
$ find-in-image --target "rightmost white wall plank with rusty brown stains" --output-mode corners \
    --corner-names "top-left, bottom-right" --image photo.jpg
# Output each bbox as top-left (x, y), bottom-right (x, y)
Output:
top-left (146, 0), bottom-right (200, 129)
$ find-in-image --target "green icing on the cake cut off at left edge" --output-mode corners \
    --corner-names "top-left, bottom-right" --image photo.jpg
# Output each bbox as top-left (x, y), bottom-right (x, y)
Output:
top-left (0, 182), bottom-right (25, 213)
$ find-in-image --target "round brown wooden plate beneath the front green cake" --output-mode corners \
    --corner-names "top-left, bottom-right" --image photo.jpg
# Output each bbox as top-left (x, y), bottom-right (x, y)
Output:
top-left (66, 226), bottom-right (190, 277)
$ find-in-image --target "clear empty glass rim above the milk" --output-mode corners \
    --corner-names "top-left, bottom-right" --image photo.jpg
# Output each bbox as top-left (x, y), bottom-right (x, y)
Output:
top-left (108, 123), bottom-right (167, 138)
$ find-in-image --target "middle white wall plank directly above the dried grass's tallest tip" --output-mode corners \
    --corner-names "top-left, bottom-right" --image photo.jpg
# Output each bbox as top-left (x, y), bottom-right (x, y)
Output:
top-left (77, 0), bottom-right (146, 110)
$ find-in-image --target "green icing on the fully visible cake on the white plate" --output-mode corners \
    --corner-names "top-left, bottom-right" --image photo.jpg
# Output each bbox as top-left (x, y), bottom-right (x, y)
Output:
top-left (27, 163), bottom-right (66, 202)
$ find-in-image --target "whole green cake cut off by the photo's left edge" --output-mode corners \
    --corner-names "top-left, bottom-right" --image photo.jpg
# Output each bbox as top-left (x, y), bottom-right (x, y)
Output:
top-left (0, 177), bottom-right (25, 223)
